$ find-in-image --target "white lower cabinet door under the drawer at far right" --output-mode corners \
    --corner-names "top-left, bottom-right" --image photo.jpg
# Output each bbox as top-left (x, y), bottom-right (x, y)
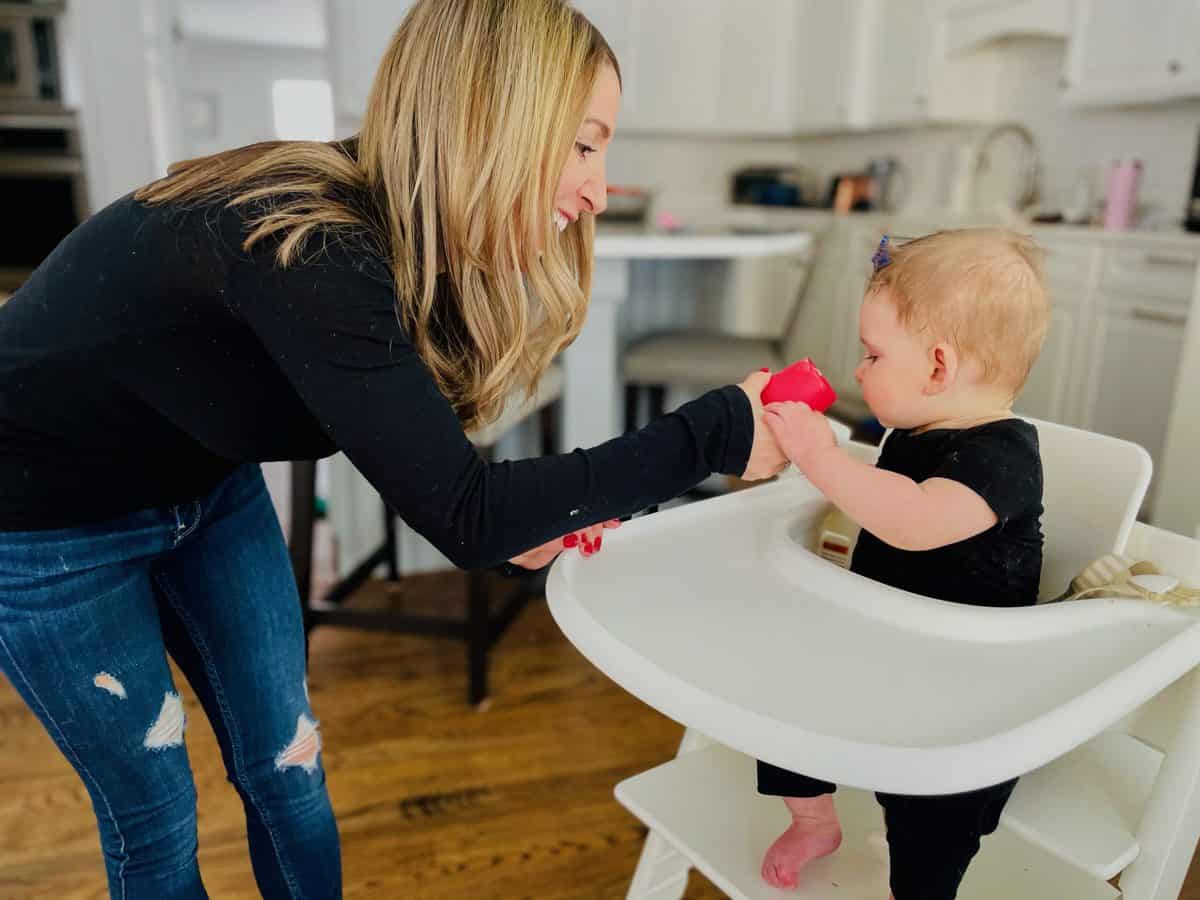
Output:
top-left (1080, 304), bottom-right (1187, 489)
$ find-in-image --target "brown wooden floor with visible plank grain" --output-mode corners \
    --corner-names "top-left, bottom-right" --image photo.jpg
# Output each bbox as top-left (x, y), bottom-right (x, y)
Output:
top-left (0, 576), bottom-right (1200, 900)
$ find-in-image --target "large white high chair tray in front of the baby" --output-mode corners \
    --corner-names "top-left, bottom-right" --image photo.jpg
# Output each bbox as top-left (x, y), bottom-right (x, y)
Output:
top-left (547, 478), bottom-right (1200, 794)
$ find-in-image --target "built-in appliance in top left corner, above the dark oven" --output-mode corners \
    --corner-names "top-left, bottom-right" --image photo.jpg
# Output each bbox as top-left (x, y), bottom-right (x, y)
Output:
top-left (0, 1), bottom-right (65, 101)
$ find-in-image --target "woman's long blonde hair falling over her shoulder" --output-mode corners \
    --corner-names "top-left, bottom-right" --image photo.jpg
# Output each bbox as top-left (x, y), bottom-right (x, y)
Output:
top-left (137, 0), bottom-right (620, 428)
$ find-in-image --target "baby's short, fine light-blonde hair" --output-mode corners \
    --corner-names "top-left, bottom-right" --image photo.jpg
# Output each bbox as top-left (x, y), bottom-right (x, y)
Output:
top-left (866, 228), bottom-right (1050, 396)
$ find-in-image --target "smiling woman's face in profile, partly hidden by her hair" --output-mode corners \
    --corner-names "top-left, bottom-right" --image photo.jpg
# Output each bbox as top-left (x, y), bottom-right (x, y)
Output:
top-left (553, 66), bottom-right (620, 232)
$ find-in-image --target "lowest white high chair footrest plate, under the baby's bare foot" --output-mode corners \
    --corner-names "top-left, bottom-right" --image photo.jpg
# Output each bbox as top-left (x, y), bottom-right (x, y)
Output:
top-left (616, 745), bottom-right (1121, 900)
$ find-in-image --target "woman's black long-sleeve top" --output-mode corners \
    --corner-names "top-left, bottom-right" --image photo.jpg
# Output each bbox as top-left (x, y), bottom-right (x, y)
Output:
top-left (0, 197), bottom-right (754, 568)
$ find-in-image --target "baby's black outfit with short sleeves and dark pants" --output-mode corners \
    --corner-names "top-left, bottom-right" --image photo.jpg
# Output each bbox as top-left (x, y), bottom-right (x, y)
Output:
top-left (758, 419), bottom-right (1042, 900)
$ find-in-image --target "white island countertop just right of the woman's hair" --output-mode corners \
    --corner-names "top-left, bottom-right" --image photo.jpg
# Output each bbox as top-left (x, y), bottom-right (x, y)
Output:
top-left (595, 226), bottom-right (812, 259)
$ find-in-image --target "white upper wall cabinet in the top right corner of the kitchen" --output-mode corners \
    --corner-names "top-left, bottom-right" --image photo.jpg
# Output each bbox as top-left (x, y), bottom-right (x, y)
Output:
top-left (1066, 0), bottom-right (1200, 106)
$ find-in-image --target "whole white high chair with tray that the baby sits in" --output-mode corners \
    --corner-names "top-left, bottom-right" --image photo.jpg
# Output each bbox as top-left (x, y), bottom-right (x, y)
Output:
top-left (547, 422), bottom-right (1200, 900)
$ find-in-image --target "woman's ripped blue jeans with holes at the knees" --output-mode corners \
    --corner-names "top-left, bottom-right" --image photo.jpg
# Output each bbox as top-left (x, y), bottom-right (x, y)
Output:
top-left (0, 466), bottom-right (341, 900)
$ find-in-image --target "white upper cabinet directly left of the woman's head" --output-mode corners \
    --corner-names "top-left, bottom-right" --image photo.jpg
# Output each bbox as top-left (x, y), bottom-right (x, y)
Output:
top-left (326, 0), bottom-right (415, 120)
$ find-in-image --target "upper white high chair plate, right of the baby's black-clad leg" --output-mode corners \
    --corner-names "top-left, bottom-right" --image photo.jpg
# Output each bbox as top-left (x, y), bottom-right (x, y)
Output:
top-left (1002, 733), bottom-right (1163, 880)
